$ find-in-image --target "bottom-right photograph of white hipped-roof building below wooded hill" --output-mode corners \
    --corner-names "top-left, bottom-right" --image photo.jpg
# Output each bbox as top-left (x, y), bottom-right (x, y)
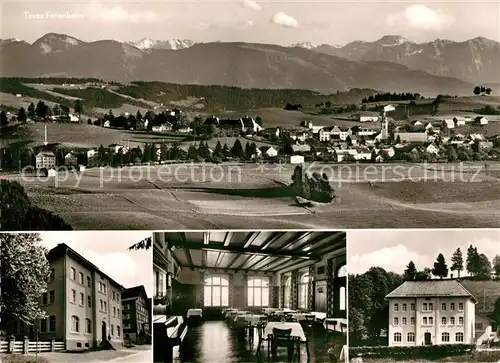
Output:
top-left (348, 229), bottom-right (500, 363)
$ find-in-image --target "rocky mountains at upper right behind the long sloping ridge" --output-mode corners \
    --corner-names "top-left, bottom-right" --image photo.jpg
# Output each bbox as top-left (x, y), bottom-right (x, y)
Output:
top-left (313, 36), bottom-right (500, 86)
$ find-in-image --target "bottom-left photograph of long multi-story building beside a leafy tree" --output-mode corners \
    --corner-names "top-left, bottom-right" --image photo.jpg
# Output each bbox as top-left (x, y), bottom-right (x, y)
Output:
top-left (0, 231), bottom-right (153, 363)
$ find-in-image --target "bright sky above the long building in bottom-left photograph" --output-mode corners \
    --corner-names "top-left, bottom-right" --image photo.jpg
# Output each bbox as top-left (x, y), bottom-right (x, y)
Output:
top-left (40, 231), bottom-right (153, 297)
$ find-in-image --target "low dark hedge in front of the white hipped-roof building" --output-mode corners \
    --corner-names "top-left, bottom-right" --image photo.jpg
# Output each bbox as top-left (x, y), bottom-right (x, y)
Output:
top-left (349, 344), bottom-right (475, 360)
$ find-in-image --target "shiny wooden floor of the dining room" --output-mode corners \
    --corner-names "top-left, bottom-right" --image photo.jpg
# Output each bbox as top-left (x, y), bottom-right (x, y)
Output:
top-left (181, 321), bottom-right (346, 363)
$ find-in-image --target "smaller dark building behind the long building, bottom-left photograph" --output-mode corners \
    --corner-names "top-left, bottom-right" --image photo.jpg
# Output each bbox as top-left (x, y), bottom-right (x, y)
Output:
top-left (122, 285), bottom-right (151, 343)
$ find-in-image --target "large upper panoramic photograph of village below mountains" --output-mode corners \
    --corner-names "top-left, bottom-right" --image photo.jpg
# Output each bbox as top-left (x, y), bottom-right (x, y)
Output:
top-left (0, 0), bottom-right (500, 231)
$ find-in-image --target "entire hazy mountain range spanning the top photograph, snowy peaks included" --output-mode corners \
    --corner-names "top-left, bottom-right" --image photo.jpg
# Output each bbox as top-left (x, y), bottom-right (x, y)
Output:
top-left (0, 33), bottom-right (500, 94)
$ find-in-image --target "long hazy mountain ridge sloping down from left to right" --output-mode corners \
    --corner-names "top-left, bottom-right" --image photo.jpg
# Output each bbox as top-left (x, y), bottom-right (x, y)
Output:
top-left (0, 34), bottom-right (472, 95)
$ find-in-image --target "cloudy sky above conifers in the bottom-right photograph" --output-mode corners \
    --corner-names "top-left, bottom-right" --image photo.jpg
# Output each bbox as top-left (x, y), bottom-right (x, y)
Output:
top-left (347, 229), bottom-right (500, 276)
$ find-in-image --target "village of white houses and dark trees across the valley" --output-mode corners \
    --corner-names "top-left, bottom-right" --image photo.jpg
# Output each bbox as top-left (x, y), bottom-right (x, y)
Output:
top-left (0, 98), bottom-right (500, 175)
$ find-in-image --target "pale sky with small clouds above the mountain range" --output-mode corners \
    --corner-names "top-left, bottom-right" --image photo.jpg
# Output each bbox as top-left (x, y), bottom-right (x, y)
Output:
top-left (0, 0), bottom-right (500, 45)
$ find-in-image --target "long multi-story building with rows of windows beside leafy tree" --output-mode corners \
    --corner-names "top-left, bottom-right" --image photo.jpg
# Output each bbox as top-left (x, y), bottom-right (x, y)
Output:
top-left (24, 243), bottom-right (124, 350)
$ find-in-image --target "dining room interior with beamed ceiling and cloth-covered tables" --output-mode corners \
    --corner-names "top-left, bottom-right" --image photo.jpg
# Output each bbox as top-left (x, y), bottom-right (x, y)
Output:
top-left (153, 231), bottom-right (347, 363)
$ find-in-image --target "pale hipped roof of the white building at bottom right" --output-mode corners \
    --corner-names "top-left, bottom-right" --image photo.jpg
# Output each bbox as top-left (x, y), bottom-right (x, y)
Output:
top-left (386, 280), bottom-right (477, 302)
